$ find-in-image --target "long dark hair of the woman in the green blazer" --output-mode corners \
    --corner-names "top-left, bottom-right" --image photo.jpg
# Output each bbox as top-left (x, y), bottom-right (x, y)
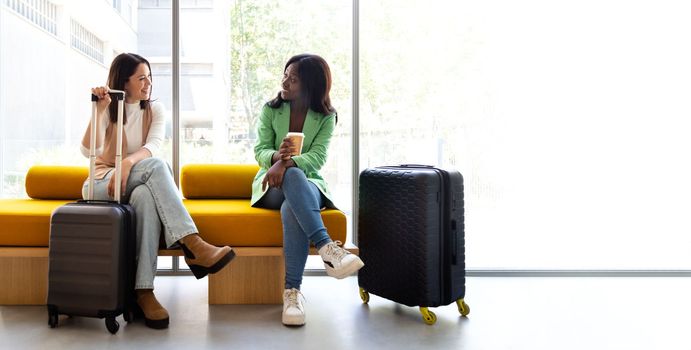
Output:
top-left (267, 54), bottom-right (338, 121)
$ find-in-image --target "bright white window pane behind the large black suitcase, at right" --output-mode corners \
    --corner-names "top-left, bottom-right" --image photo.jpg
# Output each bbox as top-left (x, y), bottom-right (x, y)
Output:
top-left (360, 0), bottom-right (691, 269)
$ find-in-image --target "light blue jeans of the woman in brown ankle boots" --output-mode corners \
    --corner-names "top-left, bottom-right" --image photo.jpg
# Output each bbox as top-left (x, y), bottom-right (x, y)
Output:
top-left (82, 158), bottom-right (197, 289)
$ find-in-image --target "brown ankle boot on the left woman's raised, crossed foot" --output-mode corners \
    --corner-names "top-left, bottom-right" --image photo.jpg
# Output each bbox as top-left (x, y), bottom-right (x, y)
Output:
top-left (179, 234), bottom-right (235, 279)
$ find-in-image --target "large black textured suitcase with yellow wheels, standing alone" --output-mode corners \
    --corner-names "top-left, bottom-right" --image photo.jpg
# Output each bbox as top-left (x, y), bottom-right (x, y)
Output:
top-left (358, 165), bottom-right (469, 324)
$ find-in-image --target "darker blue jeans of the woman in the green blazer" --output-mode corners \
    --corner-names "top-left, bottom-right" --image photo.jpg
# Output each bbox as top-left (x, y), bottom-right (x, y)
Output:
top-left (255, 167), bottom-right (331, 289)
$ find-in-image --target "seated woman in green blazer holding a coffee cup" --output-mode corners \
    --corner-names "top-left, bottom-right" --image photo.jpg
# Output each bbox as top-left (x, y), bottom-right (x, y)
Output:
top-left (252, 54), bottom-right (364, 325)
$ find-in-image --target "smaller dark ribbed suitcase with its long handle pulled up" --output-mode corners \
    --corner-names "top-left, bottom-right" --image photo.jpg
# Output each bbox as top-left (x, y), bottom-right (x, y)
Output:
top-left (47, 92), bottom-right (136, 334)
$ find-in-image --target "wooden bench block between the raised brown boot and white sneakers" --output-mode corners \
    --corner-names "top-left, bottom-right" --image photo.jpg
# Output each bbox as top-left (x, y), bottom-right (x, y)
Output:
top-left (208, 248), bottom-right (285, 304)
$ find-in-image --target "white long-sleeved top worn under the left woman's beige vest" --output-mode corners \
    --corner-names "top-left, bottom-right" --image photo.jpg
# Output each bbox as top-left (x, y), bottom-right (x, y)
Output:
top-left (80, 102), bottom-right (167, 158)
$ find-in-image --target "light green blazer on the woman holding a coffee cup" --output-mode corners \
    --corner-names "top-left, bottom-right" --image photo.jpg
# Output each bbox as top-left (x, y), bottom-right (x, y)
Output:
top-left (251, 102), bottom-right (336, 207)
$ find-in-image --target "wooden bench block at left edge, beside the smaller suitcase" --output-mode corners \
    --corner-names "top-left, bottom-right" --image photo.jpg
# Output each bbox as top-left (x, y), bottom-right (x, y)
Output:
top-left (0, 247), bottom-right (48, 305)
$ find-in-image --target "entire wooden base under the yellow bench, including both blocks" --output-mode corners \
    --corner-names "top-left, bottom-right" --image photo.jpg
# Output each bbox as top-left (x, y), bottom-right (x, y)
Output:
top-left (0, 247), bottom-right (358, 305)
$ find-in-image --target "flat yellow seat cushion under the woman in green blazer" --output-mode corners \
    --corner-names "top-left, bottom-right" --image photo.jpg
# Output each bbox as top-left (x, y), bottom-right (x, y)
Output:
top-left (184, 199), bottom-right (346, 247)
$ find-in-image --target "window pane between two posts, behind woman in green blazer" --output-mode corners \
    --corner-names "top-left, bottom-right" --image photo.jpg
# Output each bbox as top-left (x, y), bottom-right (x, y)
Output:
top-left (180, 0), bottom-right (352, 224)
